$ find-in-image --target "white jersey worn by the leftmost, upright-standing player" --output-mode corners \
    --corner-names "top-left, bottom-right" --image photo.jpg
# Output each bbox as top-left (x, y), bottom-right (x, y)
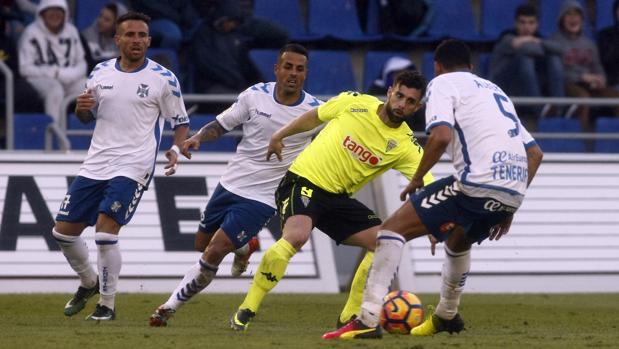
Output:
top-left (78, 58), bottom-right (189, 185)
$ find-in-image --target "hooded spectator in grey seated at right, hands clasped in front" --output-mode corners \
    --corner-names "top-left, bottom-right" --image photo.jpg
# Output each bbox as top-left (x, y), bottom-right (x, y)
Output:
top-left (553, 0), bottom-right (619, 130)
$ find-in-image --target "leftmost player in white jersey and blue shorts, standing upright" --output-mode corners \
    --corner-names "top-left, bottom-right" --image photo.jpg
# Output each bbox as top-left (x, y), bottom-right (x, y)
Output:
top-left (52, 12), bottom-right (189, 320)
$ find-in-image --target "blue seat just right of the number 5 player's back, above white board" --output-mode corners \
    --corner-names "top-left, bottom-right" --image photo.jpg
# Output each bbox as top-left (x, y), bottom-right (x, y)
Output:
top-left (537, 117), bottom-right (585, 153)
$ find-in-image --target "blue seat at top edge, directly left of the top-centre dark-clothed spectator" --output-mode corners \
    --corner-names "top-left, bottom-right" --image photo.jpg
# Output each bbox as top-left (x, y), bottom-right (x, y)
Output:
top-left (306, 0), bottom-right (382, 42)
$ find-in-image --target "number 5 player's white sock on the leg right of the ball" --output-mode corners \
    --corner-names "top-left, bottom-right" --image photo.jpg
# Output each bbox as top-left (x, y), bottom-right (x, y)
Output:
top-left (434, 245), bottom-right (471, 320)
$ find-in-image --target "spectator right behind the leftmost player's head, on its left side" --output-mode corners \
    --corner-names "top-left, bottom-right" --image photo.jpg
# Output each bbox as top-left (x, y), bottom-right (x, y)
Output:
top-left (82, 2), bottom-right (127, 70)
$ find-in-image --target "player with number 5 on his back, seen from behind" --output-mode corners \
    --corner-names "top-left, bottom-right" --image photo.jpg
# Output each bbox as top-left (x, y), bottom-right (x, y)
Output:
top-left (323, 40), bottom-right (543, 339)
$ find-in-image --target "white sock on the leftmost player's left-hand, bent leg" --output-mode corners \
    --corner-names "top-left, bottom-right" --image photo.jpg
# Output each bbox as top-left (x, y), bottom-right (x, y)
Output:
top-left (52, 228), bottom-right (97, 288)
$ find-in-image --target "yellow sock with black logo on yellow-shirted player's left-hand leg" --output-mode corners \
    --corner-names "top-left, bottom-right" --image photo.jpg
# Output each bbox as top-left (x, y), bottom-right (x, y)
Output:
top-left (239, 239), bottom-right (297, 313)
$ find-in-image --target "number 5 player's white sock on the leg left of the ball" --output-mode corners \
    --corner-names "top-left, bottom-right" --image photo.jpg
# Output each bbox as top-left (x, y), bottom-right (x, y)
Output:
top-left (359, 230), bottom-right (406, 327)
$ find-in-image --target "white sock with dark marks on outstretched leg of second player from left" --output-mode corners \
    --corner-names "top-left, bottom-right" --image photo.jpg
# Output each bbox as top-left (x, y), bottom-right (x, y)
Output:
top-left (164, 258), bottom-right (218, 310)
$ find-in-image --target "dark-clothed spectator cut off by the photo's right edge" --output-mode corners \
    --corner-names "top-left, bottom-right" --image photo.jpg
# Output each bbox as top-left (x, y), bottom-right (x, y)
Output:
top-left (597, 0), bottom-right (619, 90)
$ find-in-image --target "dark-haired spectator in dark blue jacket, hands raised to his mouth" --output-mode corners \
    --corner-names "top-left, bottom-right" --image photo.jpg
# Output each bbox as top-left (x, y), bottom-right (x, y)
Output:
top-left (488, 4), bottom-right (565, 104)
